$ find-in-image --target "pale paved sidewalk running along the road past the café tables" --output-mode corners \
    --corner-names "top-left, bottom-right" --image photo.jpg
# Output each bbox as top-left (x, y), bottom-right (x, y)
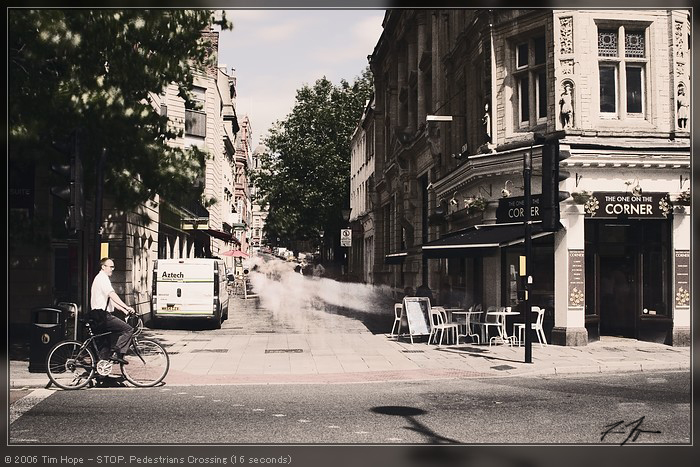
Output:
top-left (9, 329), bottom-right (690, 389)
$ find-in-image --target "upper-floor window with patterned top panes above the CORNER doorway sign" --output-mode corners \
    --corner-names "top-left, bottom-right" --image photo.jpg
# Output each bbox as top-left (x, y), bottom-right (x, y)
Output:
top-left (598, 26), bottom-right (648, 119)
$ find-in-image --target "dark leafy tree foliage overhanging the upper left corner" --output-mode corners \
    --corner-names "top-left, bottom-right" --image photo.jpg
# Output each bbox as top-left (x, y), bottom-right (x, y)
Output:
top-left (8, 9), bottom-right (230, 214)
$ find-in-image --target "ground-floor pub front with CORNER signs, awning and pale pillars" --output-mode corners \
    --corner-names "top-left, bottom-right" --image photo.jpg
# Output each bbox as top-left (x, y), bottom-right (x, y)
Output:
top-left (422, 143), bottom-right (691, 345)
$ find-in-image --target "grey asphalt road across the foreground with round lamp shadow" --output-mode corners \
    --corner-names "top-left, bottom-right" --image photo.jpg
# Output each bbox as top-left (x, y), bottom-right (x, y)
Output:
top-left (10, 372), bottom-right (691, 445)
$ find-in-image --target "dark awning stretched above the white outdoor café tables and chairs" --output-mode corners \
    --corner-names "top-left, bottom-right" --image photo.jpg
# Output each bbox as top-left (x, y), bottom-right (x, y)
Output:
top-left (423, 222), bottom-right (553, 258)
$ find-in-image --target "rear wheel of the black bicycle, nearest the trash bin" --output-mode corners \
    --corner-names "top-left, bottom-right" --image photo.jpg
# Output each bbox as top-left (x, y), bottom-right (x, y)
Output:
top-left (46, 341), bottom-right (97, 389)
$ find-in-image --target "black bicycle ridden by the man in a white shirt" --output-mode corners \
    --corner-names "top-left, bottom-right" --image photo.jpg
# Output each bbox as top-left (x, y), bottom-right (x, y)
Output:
top-left (46, 317), bottom-right (170, 389)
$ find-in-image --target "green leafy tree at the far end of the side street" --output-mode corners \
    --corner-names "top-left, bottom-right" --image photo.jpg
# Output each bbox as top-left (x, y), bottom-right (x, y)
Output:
top-left (254, 68), bottom-right (372, 244)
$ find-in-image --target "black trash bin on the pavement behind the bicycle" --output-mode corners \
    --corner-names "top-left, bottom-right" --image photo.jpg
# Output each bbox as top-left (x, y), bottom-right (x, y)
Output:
top-left (29, 307), bottom-right (68, 373)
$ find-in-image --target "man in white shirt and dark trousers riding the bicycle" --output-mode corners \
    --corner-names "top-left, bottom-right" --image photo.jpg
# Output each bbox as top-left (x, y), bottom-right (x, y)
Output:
top-left (90, 258), bottom-right (134, 364)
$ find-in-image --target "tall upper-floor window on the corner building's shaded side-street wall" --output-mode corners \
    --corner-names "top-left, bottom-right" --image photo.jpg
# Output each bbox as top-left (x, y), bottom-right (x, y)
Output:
top-left (514, 35), bottom-right (547, 128)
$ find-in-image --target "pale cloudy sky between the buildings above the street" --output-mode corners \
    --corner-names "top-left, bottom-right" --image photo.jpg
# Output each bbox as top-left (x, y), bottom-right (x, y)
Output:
top-left (219, 9), bottom-right (384, 148)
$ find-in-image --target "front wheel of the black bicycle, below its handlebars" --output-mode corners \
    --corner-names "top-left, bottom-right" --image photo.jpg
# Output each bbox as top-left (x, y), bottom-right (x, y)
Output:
top-left (121, 339), bottom-right (170, 387)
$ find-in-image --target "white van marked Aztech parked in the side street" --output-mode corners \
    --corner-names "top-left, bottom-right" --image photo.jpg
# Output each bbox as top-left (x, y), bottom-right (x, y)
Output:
top-left (151, 258), bottom-right (229, 329)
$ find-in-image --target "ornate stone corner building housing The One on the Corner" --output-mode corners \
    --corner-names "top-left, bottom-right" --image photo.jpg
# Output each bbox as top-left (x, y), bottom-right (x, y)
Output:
top-left (370, 9), bottom-right (691, 346)
